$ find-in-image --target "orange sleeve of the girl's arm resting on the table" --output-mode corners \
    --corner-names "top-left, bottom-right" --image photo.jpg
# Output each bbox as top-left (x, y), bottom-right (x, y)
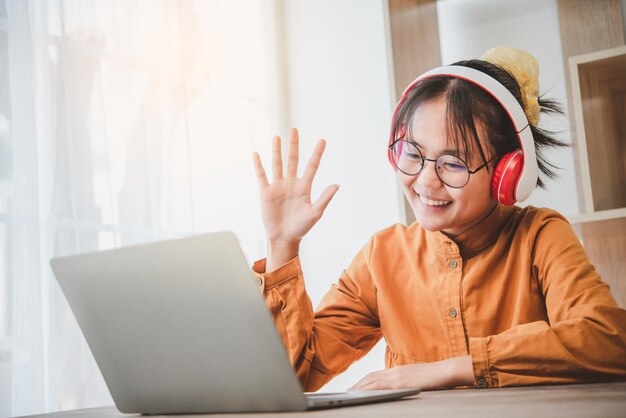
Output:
top-left (470, 217), bottom-right (626, 387)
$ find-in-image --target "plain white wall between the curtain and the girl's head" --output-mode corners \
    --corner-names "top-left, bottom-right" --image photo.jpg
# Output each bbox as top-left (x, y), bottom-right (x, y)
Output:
top-left (284, 0), bottom-right (400, 391)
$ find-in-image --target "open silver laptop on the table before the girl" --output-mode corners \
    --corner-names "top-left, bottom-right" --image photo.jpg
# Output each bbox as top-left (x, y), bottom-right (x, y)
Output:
top-left (50, 232), bottom-right (420, 414)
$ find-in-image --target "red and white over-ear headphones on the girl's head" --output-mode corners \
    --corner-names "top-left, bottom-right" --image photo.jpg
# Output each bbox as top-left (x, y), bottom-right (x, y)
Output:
top-left (387, 65), bottom-right (539, 205)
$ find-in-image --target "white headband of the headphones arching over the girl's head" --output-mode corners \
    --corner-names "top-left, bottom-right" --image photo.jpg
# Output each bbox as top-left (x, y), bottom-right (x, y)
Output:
top-left (388, 65), bottom-right (539, 201)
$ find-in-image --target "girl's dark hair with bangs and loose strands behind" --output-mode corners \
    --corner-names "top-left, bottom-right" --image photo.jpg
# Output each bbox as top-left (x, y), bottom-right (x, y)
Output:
top-left (392, 60), bottom-right (568, 188)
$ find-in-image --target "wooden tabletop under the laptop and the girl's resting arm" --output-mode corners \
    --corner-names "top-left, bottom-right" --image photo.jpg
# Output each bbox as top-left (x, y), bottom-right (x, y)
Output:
top-left (17, 382), bottom-right (626, 418)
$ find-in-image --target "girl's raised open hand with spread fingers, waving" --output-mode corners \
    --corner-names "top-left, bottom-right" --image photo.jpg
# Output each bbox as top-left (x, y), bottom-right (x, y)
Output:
top-left (253, 128), bottom-right (339, 271)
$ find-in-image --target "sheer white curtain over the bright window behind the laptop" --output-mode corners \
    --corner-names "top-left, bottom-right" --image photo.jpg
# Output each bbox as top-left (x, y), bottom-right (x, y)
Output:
top-left (0, 0), bottom-right (284, 416)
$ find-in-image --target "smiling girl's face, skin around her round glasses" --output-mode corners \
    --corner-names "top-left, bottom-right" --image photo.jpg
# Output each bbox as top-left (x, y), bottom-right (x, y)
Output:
top-left (397, 97), bottom-right (496, 236)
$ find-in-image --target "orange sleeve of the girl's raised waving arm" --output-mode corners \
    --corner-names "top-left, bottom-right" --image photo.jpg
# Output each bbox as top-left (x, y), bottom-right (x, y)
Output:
top-left (252, 240), bottom-right (381, 391)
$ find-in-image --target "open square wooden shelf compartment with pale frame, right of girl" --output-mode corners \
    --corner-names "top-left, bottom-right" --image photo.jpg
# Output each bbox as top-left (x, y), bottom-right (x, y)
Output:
top-left (569, 46), bottom-right (626, 214)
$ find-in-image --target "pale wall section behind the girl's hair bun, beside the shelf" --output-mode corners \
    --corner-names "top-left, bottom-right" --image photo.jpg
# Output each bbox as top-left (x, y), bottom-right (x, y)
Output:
top-left (437, 0), bottom-right (579, 215)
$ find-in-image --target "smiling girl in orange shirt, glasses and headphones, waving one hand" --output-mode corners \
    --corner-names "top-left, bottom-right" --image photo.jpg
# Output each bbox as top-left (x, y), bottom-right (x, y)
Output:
top-left (253, 47), bottom-right (626, 391)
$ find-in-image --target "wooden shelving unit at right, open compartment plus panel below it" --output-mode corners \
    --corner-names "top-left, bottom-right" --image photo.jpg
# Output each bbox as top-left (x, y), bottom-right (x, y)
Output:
top-left (569, 46), bottom-right (626, 307)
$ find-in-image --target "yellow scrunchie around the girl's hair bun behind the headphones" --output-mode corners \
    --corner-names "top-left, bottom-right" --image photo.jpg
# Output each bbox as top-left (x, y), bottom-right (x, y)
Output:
top-left (480, 46), bottom-right (541, 126)
